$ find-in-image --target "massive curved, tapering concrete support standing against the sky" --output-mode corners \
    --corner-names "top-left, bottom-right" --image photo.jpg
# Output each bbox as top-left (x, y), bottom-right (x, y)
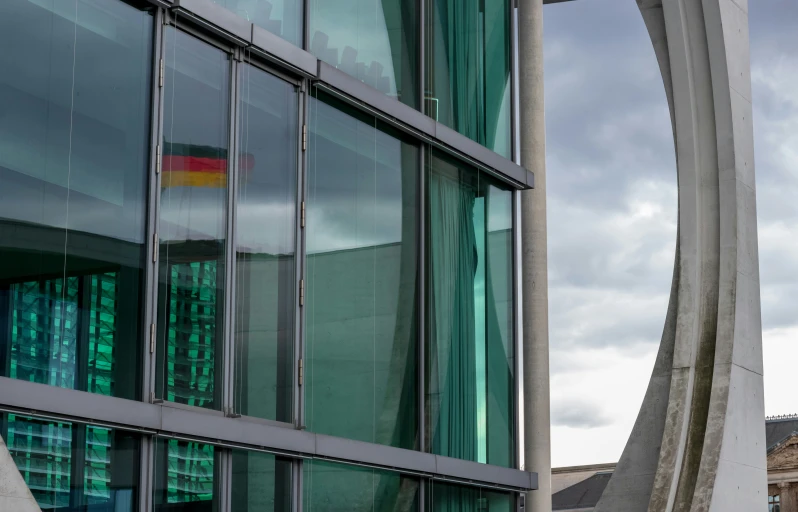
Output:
top-left (595, 0), bottom-right (767, 512)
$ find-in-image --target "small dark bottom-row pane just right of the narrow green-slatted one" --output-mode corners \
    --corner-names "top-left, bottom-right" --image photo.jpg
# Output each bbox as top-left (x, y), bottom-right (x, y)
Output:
top-left (230, 450), bottom-right (291, 512)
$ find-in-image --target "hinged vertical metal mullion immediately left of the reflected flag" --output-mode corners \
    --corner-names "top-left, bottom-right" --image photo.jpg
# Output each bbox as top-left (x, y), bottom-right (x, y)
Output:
top-left (141, 9), bottom-right (166, 404)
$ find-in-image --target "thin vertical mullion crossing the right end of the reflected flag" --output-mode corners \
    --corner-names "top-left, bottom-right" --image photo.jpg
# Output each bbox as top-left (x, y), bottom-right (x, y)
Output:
top-left (223, 52), bottom-right (241, 415)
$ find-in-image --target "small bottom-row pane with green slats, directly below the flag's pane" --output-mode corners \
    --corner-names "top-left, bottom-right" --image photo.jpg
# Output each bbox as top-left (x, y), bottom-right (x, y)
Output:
top-left (153, 439), bottom-right (219, 512)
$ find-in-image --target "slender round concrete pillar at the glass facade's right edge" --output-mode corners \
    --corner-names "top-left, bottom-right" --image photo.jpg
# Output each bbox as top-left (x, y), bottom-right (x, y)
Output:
top-left (518, 0), bottom-right (551, 512)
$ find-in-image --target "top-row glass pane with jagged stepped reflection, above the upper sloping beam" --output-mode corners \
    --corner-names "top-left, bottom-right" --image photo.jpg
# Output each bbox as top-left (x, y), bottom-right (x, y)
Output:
top-left (310, 0), bottom-right (420, 108)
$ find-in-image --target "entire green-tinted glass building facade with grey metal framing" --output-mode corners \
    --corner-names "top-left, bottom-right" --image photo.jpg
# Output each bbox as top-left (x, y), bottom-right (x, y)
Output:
top-left (0, 0), bottom-right (536, 512)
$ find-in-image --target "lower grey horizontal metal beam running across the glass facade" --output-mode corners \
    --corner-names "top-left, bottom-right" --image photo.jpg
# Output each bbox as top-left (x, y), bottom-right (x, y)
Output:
top-left (0, 377), bottom-right (538, 491)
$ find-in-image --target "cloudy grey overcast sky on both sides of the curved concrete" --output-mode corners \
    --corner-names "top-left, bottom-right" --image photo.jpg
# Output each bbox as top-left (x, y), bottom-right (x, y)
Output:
top-left (544, 0), bottom-right (798, 467)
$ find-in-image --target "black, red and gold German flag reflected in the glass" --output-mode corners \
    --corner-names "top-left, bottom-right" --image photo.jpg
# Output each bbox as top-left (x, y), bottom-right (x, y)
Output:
top-left (161, 143), bottom-right (255, 188)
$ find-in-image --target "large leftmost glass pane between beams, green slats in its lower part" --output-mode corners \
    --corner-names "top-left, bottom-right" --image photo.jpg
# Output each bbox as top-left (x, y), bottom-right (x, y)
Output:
top-left (0, 0), bottom-right (153, 399)
